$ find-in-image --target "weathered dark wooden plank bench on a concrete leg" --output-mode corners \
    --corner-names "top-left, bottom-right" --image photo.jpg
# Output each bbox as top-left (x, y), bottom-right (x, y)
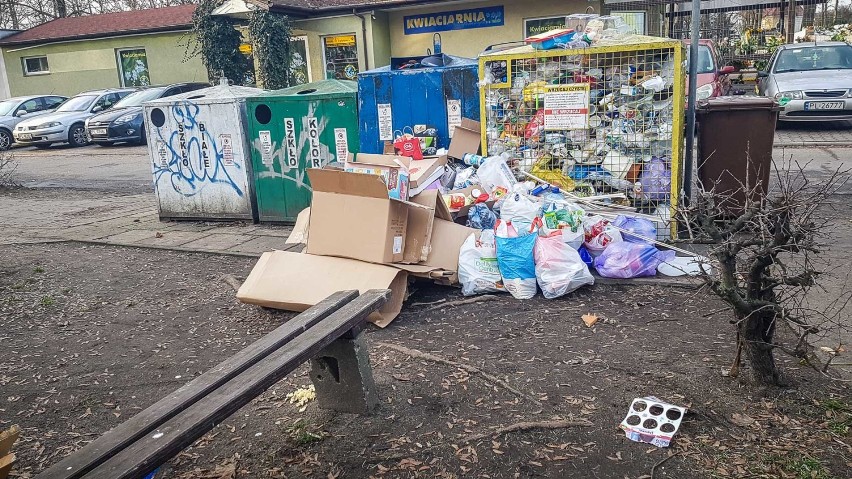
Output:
top-left (37, 290), bottom-right (390, 479)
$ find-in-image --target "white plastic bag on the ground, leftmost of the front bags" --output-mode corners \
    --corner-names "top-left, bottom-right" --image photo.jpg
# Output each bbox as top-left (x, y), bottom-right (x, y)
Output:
top-left (459, 230), bottom-right (506, 296)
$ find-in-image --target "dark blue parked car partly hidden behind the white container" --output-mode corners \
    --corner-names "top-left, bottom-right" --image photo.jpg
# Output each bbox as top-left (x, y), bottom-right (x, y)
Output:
top-left (86, 83), bottom-right (210, 146)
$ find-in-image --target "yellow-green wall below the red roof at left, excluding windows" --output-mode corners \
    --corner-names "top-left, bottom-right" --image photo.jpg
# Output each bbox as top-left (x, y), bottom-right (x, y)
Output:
top-left (3, 32), bottom-right (208, 96)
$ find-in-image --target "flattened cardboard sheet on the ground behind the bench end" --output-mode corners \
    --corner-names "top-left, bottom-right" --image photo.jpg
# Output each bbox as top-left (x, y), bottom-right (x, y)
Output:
top-left (237, 251), bottom-right (408, 328)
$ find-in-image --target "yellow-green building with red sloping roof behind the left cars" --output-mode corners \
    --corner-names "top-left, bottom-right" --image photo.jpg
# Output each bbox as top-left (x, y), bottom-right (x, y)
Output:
top-left (0, 5), bottom-right (208, 96)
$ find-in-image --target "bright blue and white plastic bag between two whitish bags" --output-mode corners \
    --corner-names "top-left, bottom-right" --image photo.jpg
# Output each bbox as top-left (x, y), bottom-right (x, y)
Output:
top-left (495, 220), bottom-right (538, 299)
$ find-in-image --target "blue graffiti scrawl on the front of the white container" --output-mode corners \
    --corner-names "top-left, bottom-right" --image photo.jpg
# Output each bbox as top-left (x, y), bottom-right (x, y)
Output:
top-left (154, 101), bottom-right (244, 196)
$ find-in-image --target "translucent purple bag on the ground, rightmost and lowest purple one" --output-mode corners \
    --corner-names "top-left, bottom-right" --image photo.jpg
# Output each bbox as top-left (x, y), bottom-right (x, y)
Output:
top-left (595, 241), bottom-right (675, 279)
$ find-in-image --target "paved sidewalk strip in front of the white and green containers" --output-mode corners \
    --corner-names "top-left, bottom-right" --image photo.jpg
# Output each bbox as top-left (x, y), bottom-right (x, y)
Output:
top-left (0, 189), bottom-right (292, 256)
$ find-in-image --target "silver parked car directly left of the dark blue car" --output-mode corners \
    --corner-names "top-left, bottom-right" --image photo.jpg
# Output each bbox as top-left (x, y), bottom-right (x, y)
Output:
top-left (14, 88), bottom-right (136, 148)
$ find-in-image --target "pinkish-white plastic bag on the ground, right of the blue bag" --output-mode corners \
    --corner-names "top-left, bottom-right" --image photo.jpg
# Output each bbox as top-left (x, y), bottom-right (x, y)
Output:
top-left (535, 231), bottom-right (595, 299)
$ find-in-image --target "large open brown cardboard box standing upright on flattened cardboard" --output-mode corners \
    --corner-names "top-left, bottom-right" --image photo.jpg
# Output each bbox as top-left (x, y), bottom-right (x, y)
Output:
top-left (307, 168), bottom-right (435, 263)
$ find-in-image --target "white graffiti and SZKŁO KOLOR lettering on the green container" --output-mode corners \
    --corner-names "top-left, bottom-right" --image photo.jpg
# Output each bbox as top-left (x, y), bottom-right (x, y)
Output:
top-left (251, 104), bottom-right (332, 190)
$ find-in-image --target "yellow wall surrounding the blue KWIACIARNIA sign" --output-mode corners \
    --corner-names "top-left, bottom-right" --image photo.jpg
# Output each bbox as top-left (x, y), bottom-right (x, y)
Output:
top-left (388, 0), bottom-right (600, 58)
